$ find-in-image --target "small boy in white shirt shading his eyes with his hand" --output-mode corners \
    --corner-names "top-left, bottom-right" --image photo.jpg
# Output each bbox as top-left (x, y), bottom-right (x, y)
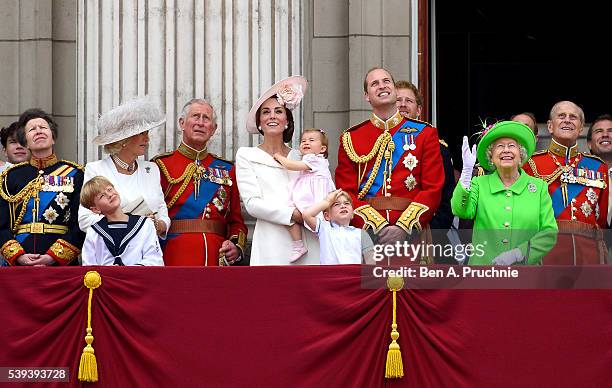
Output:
top-left (302, 189), bottom-right (374, 264)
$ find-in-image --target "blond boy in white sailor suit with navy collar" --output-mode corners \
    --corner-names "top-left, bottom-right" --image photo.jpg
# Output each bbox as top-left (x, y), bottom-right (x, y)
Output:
top-left (81, 176), bottom-right (164, 266)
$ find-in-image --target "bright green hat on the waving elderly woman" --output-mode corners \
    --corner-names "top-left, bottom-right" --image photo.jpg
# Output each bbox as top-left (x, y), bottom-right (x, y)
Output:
top-left (476, 121), bottom-right (536, 171)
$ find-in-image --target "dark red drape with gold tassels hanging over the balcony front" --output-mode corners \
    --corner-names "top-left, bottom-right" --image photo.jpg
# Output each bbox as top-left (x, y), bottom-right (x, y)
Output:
top-left (0, 266), bottom-right (612, 387)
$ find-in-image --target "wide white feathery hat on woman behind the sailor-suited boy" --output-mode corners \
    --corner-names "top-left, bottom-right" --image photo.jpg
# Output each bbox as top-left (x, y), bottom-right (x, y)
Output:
top-left (93, 96), bottom-right (166, 145)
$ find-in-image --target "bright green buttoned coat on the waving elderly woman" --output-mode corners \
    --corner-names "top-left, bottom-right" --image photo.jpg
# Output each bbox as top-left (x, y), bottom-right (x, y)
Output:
top-left (451, 169), bottom-right (558, 265)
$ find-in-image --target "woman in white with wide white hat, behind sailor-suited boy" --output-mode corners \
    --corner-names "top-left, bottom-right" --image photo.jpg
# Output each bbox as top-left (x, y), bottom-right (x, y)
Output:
top-left (79, 97), bottom-right (170, 237)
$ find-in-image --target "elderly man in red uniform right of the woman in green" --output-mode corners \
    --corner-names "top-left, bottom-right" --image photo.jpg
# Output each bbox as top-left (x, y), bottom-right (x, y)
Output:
top-left (523, 101), bottom-right (609, 264)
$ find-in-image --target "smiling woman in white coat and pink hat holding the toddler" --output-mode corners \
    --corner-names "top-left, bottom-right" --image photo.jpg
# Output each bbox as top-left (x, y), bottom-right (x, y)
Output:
top-left (236, 76), bottom-right (319, 265)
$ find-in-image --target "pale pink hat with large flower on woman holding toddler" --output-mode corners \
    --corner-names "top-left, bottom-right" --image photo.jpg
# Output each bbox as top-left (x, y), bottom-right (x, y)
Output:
top-left (247, 75), bottom-right (308, 133)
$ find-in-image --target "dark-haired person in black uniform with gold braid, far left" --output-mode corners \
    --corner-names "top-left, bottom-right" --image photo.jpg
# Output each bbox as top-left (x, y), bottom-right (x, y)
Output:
top-left (0, 109), bottom-right (85, 266)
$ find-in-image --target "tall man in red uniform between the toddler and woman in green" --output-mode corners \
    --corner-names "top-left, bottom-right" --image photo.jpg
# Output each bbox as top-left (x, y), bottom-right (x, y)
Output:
top-left (336, 68), bottom-right (444, 258)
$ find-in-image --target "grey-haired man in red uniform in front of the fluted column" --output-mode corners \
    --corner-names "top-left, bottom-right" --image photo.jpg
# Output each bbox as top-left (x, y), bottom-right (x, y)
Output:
top-left (153, 99), bottom-right (247, 266)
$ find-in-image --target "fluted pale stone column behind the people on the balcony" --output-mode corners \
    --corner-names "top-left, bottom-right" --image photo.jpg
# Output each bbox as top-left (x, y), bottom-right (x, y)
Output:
top-left (78, 0), bottom-right (303, 161)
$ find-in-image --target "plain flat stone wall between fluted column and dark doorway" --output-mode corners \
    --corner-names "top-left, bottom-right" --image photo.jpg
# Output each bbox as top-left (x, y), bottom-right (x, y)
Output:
top-left (304, 0), bottom-right (417, 168)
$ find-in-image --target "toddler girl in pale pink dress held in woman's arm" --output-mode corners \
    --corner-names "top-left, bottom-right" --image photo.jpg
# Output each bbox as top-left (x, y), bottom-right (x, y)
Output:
top-left (274, 128), bottom-right (336, 262)
